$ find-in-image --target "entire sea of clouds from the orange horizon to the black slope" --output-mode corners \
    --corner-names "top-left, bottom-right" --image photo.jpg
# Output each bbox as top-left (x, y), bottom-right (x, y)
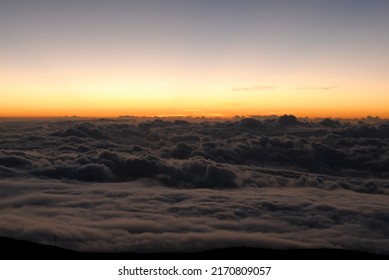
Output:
top-left (0, 118), bottom-right (389, 253)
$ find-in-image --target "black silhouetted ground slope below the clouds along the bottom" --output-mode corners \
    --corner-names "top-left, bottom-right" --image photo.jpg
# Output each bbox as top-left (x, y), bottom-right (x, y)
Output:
top-left (0, 237), bottom-right (389, 260)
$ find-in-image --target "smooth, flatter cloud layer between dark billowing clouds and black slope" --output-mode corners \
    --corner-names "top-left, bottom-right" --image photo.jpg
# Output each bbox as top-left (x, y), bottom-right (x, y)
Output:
top-left (0, 180), bottom-right (389, 253)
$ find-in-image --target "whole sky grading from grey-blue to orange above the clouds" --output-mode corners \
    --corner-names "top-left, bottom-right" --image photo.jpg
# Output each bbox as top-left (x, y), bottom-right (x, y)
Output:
top-left (0, 0), bottom-right (389, 117)
